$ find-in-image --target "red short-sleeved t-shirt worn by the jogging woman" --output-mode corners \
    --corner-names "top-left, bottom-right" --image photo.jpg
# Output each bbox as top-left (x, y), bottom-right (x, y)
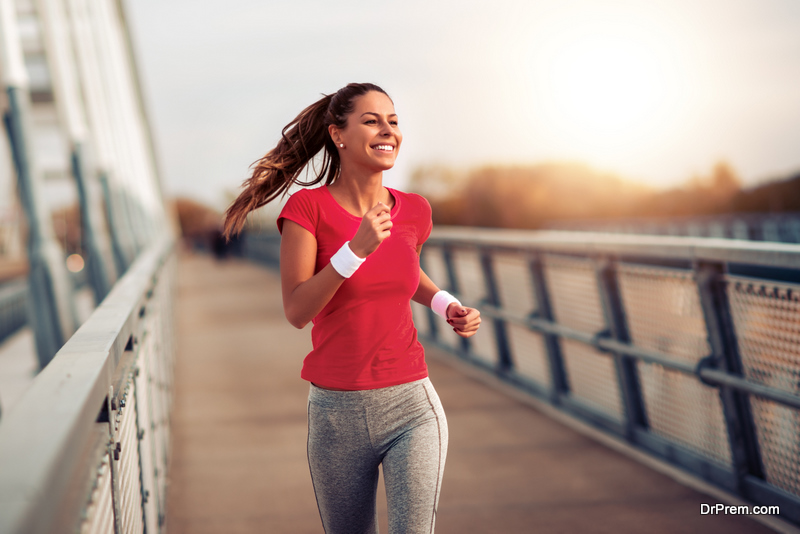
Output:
top-left (278, 186), bottom-right (432, 389)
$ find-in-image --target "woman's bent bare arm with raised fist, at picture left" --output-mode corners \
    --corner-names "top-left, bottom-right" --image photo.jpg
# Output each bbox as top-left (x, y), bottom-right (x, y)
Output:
top-left (281, 202), bottom-right (392, 328)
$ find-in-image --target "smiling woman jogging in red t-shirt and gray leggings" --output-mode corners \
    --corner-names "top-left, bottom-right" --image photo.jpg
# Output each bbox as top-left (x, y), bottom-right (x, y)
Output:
top-left (224, 83), bottom-right (481, 534)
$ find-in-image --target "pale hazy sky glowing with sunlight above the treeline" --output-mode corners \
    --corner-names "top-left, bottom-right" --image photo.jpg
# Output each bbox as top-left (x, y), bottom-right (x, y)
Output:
top-left (126, 0), bottom-right (800, 208)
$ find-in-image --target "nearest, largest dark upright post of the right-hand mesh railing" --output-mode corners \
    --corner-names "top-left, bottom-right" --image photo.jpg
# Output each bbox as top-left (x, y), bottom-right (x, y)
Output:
top-left (695, 262), bottom-right (763, 489)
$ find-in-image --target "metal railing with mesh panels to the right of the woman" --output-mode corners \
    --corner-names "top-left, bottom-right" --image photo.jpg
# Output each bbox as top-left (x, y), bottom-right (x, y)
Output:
top-left (412, 228), bottom-right (800, 523)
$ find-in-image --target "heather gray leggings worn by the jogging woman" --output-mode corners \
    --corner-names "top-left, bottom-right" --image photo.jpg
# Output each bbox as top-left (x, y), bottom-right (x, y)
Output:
top-left (308, 378), bottom-right (447, 534)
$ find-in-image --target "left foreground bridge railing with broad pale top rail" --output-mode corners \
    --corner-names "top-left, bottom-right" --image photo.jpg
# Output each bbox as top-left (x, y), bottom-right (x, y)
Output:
top-left (0, 239), bottom-right (176, 534)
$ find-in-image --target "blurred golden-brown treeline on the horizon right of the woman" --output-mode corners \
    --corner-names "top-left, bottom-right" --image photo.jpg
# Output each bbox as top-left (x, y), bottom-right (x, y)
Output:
top-left (410, 157), bottom-right (788, 228)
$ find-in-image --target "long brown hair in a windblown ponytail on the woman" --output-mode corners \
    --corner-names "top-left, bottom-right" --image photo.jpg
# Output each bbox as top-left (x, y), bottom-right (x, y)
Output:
top-left (223, 83), bottom-right (389, 239)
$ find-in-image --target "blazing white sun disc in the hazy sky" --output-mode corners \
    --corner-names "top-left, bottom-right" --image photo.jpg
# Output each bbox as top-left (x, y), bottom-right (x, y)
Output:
top-left (532, 4), bottom-right (691, 176)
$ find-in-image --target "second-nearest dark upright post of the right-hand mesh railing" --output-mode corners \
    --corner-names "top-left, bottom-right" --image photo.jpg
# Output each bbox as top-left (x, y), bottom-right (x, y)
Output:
top-left (595, 258), bottom-right (647, 439)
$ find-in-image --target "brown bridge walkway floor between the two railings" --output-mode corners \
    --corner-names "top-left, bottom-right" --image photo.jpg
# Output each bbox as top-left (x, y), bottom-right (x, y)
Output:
top-left (167, 255), bottom-right (771, 534)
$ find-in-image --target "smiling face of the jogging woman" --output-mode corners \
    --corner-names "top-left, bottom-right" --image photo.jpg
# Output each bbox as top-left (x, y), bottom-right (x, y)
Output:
top-left (328, 91), bottom-right (403, 172)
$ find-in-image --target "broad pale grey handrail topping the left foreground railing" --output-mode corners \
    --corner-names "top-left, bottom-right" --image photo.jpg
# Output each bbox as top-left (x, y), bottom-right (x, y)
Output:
top-left (0, 237), bottom-right (174, 534)
